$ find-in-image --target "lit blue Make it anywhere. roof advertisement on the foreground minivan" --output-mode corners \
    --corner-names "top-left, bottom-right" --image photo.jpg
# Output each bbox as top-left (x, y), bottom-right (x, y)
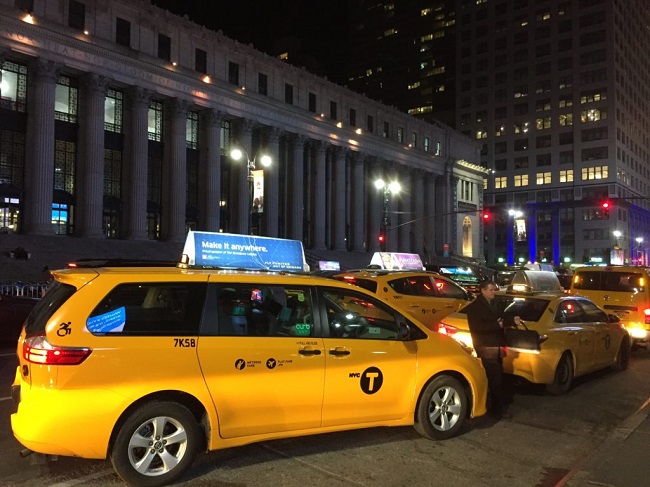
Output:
top-left (183, 232), bottom-right (308, 272)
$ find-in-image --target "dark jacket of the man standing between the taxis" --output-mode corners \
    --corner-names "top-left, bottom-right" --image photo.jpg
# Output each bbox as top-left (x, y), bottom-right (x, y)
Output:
top-left (465, 295), bottom-right (506, 358)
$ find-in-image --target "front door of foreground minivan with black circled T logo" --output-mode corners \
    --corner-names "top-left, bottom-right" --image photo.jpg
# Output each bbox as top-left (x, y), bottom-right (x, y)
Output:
top-left (320, 289), bottom-right (417, 427)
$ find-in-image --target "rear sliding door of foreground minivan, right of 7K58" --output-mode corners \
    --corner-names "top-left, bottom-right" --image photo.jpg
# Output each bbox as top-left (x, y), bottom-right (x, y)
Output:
top-left (198, 282), bottom-right (325, 438)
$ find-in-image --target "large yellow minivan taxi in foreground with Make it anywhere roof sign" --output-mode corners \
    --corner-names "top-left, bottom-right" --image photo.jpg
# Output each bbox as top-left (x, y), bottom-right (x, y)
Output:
top-left (11, 232), bottom-right (487, 487)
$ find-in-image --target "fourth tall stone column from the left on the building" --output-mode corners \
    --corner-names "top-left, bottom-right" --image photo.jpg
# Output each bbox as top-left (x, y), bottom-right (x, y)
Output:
top-left (163, 98), bottom-right (189, 242)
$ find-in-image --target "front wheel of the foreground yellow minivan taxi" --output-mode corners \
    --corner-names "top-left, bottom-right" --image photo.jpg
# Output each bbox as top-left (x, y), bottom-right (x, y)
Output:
top-left (414, 375), bottom-right (469, 440)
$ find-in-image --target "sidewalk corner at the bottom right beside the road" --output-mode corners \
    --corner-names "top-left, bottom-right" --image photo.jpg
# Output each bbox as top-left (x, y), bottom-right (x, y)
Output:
top-left (555, 399), bottom-right (650, 487)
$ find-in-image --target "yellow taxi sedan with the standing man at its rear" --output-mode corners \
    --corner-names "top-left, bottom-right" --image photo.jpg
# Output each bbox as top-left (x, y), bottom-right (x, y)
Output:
top-left (438, 290), bottom-right (631, 394)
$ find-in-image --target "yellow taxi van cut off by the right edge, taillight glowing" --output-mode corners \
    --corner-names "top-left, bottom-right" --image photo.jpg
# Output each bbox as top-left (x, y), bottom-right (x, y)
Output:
top-left (569, 266), bottom-right (650, 345)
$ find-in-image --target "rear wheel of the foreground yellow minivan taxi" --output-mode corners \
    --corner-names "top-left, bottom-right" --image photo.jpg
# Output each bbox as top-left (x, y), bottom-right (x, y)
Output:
top-left (110, 402), bottom-right (203, 487)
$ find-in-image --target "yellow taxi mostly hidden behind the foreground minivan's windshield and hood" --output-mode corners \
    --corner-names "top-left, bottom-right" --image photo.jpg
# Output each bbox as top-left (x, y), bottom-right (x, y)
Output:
top-left (333, 269), bottom-right (473, 331)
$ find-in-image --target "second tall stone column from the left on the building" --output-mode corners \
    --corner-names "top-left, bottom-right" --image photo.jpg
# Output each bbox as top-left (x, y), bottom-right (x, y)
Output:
top-left (77, 73), bottom-right (108, 238)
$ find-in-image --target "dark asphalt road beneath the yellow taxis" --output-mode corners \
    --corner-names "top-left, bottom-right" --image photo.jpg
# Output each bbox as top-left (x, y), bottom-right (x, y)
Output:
top-left (0, 350), bottom-right (650, 487)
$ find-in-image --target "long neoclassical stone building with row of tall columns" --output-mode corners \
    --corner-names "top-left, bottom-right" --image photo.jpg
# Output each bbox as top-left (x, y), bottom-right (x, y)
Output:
top-left (0, 0), bottom-right (485, 266)
